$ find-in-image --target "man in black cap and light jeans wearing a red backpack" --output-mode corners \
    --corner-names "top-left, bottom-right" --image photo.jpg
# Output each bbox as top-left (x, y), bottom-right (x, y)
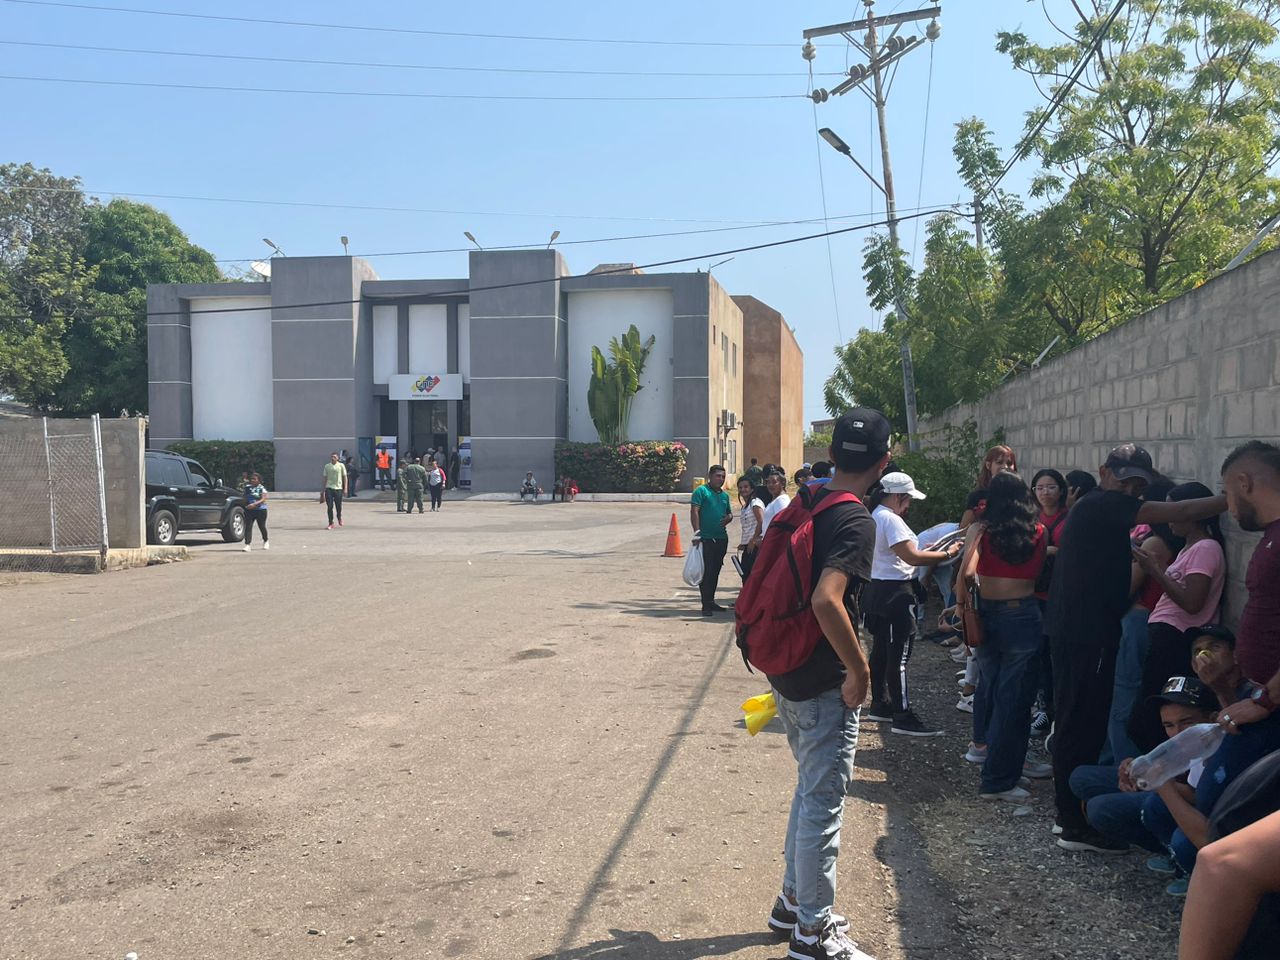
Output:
top-left (736, 407), bottom-right (890, 960)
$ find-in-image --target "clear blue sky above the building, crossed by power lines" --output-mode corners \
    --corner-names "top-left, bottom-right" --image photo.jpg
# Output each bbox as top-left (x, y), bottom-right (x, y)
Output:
top-left (0, 0), bottom-right (1068, 421)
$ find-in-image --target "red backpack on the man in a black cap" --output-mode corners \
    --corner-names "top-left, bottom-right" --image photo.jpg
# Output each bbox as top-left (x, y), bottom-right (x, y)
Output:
top-left (733, 485), bottom-right (861, 676)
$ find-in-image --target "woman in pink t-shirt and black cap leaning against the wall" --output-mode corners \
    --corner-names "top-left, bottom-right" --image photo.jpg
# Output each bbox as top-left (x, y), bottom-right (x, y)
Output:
top-left (1129, 481), bottom-right (1226, 751)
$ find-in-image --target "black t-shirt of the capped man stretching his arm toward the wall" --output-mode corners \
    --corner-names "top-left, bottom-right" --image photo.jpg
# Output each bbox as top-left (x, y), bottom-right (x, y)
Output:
top-left (1044, 489), bottom-right (1142, 645)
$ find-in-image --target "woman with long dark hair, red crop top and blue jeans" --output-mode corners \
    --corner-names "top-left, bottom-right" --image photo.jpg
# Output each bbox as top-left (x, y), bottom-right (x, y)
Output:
top-left (956, 472), bottom-right (1052, 800)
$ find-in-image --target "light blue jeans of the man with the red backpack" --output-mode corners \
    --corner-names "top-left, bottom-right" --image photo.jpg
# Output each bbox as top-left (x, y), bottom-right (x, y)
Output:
top-left (773, 687), bottom-right (858, 929)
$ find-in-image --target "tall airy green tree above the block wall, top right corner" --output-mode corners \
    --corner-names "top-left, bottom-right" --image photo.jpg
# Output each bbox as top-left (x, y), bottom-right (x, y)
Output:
top-left (997, 0), bottom-right (1280, 330)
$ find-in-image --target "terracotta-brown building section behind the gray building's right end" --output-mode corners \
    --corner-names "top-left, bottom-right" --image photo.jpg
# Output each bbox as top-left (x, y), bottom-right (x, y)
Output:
top-left (733, 297), bottom-right (804, 472)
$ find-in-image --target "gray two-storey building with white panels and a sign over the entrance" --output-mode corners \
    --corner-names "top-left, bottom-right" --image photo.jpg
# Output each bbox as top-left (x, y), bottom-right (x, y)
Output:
top-left (147, 250), bottom-right (781, 492)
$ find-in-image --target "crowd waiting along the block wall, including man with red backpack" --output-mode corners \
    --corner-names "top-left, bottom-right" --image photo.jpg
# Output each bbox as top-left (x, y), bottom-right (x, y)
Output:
top-left (716, 410), bottom-right (1280, 960)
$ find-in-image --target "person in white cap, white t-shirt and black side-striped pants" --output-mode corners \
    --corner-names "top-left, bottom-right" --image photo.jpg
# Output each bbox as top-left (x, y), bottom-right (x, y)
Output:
top-left (863, 471), bottom-right (960, 737)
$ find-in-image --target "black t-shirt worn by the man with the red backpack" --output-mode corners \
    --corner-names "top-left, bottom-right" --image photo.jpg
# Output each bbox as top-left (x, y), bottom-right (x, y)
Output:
top-left (769, 490), bottom-right (876, 700)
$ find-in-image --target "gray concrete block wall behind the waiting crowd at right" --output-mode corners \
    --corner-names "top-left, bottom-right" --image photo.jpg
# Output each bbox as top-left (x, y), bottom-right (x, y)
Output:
top-left (922, 251), bottom-right (1280, 623)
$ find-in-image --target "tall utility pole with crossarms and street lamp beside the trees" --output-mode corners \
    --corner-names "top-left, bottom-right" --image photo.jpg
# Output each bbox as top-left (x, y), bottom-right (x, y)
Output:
top-left (803, 0), bottom-right (942, 451)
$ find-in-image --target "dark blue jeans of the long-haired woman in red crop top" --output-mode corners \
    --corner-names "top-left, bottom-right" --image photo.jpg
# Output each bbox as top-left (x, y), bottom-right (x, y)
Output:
top-left (974, 596), bottom-right (1041, 794)
